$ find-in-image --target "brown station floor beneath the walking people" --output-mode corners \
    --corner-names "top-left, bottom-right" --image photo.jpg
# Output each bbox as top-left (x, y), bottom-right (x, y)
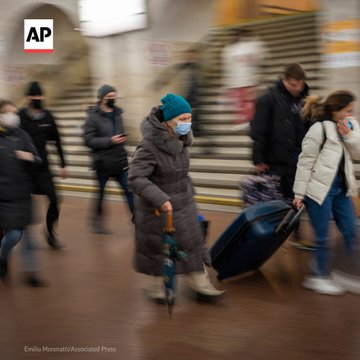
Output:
top-left (0, 197), bottom-right (360, 360)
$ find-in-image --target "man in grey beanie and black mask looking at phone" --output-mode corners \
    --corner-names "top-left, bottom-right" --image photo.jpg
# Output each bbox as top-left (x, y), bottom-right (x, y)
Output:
top-left (84, 84), bottom-right (135, 234)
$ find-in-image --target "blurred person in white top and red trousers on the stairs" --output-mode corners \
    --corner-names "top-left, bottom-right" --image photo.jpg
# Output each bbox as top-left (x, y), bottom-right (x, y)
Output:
top-left (222, 29), bottom-right (266, 124)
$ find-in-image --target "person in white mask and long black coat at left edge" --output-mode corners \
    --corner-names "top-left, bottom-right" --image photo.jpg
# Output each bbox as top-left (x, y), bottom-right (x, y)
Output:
top-left (0, 100), bottom-right (41, 280)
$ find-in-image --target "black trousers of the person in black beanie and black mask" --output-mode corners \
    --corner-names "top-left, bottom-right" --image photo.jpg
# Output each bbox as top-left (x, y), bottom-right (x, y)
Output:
top-left (34, 170), bottom-right (60, 236)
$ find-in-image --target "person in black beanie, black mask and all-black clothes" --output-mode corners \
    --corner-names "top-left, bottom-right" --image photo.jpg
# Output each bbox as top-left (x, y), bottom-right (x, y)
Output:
top-left (19, 81), bottom-right (67, 250)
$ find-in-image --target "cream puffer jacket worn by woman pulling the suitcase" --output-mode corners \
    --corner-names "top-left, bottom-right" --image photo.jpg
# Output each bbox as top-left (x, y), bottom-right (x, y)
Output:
top-left (293, 121), bottom-right (360, 205)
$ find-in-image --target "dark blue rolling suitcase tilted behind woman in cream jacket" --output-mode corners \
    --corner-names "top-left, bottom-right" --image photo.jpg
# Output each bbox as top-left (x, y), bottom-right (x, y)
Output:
top-left (210, 200), bottom-right (304, 280)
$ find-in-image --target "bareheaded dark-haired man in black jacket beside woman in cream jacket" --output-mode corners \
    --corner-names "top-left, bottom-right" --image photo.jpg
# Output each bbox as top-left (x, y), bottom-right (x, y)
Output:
top-left (250, 63), bottom-right (309, 199)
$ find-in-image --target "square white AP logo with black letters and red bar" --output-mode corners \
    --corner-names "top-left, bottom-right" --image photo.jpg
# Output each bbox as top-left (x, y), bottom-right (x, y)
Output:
top-left (24, 19), bottom-right (54, 53)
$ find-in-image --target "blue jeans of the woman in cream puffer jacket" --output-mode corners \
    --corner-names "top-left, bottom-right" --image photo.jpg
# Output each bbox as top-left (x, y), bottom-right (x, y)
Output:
top-left (305, 175), bottom-right (356, 276)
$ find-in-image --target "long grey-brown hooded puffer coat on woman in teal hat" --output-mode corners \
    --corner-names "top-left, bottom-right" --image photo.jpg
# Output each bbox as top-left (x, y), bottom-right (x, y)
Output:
top-left (129, 107), bottom-right (204, 276)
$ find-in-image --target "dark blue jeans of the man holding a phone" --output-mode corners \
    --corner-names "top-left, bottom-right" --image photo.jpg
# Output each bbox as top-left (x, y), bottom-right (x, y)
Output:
top-left (96, 171), bottom-right (135, 217)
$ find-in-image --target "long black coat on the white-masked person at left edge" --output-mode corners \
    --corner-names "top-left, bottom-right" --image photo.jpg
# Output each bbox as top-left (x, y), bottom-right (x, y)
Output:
top-left (0, 129), bottom-right (41, 229)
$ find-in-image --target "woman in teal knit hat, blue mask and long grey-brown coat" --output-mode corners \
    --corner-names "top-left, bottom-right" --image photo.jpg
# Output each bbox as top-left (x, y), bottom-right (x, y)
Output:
top-left (129, 94), bottom-right (223, 300)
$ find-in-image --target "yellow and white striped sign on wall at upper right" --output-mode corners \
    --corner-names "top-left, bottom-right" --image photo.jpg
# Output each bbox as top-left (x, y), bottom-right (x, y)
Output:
top-left (322, 19), bottom-right (360, 67)
